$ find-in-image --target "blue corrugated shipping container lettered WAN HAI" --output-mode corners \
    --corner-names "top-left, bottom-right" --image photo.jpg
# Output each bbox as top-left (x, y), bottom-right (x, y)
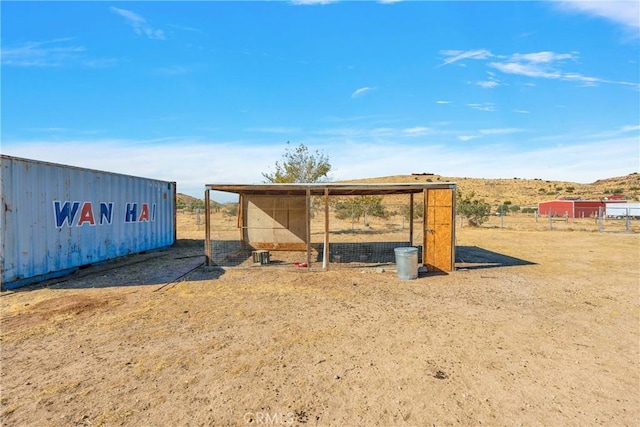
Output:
top-left (0, 155), bottom-right (176, 289)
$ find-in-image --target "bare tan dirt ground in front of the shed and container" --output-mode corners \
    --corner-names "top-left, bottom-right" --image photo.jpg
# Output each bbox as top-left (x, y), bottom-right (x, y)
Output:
top-left (0, 216), bottom-right (640, 426)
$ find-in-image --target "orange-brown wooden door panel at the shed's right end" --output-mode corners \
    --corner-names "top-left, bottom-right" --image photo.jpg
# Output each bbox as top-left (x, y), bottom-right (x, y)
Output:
top-left (422, 187), bottom-right (456, 271)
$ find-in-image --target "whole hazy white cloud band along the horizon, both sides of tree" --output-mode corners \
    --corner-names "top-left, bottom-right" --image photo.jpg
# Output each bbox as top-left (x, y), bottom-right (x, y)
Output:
top-left (2, 124), bottom-right (640, 198)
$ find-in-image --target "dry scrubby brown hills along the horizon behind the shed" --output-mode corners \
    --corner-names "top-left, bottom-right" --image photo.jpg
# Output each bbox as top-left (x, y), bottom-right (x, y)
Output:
top-left (182, 172), bottom-right (640, 206)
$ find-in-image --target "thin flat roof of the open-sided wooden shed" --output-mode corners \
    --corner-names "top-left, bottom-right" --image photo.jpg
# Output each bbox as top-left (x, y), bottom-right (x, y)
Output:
top-left (205, 182), bottom-right (456, 196)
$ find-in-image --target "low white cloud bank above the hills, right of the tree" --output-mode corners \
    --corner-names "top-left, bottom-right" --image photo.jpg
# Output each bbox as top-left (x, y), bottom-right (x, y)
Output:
top-left (327, 138), bottom-right (638, 182)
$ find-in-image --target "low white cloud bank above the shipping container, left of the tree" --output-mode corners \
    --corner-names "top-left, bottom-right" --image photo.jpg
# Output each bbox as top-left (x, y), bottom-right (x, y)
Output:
top-left (3, 138), bottom-right (283, 198)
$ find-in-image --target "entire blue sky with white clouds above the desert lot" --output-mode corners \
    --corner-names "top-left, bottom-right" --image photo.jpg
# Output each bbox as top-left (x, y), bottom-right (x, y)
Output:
top-left (0, 0), bottom-right (640, 197)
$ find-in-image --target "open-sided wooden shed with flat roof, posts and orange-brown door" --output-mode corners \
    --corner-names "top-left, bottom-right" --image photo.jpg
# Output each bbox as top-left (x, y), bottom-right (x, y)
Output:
top-left (205, 182), bottom-right (456, 271)
